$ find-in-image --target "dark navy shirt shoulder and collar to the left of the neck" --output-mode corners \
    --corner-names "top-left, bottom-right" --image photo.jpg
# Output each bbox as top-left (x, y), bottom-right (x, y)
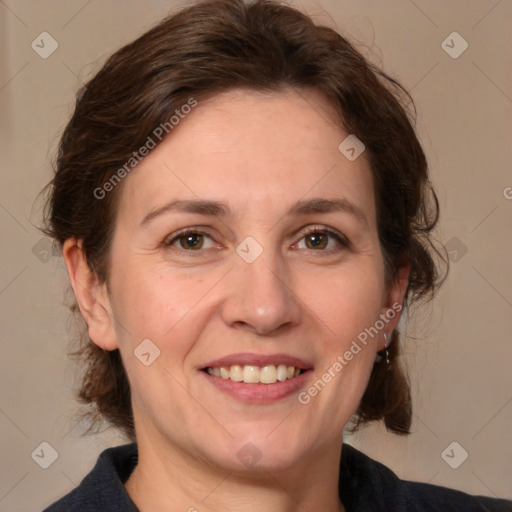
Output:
top-left (43, 444), bottom-right (137, 512)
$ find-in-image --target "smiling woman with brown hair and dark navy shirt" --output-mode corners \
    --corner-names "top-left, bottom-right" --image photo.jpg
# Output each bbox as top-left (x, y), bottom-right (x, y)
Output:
top-left (41, 0), bottom-right (512, 512)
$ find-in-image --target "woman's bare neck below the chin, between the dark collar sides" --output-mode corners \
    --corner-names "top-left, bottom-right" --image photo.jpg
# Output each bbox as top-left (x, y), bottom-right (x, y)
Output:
top-left (125, 441), bottom-right (344, 512)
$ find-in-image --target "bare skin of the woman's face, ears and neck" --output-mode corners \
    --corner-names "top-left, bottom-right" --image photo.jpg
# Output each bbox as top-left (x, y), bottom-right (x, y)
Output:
top-left (64, 90), bottom-right (407, 512)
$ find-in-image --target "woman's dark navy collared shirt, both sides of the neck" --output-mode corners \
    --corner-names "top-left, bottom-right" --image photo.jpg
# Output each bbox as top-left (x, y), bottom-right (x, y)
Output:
top-left (43, 444), bottom-right (512, 512)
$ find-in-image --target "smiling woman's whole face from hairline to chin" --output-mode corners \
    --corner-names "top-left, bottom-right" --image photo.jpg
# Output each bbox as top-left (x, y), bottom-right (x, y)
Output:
top-left (91, 90), bottom-right (403, 471)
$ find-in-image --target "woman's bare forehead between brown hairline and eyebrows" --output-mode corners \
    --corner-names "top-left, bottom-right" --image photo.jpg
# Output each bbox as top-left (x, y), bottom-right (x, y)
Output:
top-left (120, 90), bottom-right (375, 228)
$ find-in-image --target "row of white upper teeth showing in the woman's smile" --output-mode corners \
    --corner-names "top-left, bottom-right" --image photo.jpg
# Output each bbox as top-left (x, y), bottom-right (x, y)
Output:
top-left (206, 364), bottom-right (301, 384)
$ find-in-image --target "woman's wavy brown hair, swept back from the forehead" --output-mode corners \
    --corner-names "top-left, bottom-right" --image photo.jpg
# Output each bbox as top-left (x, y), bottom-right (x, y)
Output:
top-left (46, 0), bottom-right (439, 437)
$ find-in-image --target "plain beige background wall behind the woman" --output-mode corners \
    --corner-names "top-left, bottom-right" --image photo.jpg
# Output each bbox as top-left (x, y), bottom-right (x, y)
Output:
top-left (0, 0), bottom-right (512, 512)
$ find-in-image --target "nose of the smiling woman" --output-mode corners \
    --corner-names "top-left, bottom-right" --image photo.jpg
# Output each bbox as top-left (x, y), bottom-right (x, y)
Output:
top-left (221, 251), bottom-right (301, 335)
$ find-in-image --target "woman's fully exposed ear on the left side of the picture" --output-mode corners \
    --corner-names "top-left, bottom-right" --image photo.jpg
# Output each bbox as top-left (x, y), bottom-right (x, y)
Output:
top-left (62, 238), bottom-right (118, 350)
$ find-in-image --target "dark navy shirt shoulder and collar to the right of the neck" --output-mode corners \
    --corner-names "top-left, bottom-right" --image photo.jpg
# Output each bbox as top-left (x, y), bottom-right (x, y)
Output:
top-left (339, 444), bottom-right (512, 512)
